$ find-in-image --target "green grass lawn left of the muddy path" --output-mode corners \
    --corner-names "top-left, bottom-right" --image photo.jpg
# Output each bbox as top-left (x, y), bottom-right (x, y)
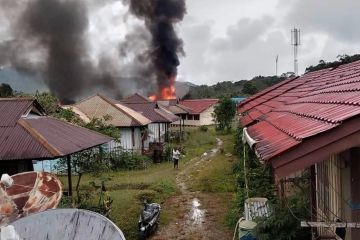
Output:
top-left (61, 128), bottom-right (216, 240)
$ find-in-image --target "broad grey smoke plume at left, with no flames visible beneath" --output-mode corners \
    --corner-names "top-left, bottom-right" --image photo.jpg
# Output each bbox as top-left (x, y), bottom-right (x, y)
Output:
top-left (0, 0), bottom-right (120, 103)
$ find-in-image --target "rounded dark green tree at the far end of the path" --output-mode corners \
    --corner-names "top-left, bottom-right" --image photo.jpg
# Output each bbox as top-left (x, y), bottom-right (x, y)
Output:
top-left (214, 97), bottom-right (236, 131)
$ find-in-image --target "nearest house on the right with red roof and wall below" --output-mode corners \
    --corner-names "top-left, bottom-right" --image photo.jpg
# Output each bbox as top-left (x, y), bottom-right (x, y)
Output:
top-left (238, 61), bottom-right (360, 240)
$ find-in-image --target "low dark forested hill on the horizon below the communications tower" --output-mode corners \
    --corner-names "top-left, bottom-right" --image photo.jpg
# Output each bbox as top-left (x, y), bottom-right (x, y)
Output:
top-left (185, 76), bottom-right (285, 99)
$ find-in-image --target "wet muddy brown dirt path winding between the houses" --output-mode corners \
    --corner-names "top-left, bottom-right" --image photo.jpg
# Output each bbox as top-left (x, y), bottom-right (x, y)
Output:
top-left (151, 138), bottom-right (232, 240)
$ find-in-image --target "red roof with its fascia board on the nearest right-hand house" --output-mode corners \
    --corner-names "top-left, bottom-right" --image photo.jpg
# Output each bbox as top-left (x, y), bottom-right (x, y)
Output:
top-left (238, 61), bottom-right (360, 175)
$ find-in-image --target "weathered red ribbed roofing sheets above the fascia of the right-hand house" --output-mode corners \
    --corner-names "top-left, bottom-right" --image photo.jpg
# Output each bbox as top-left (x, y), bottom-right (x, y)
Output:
top-left (240, 61), bottom-right (360, 175)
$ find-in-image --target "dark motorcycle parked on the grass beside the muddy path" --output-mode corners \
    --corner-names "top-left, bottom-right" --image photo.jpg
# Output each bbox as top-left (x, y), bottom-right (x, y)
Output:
top-left (138, 203), bottom-right (161, 239)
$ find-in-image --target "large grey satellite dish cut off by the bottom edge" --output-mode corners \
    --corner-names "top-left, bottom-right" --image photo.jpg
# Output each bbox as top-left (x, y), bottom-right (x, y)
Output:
top-left (0, 209), bottom-right (125, 240)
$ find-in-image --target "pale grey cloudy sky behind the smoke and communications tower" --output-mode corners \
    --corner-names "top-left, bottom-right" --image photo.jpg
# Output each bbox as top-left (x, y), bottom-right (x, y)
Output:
top-left (0, 0), bottom-right (360, 85)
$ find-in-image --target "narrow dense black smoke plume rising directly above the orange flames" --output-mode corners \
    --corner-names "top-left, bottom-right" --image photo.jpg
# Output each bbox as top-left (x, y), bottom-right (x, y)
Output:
top-left (127, 0), bottom-right (186, 96)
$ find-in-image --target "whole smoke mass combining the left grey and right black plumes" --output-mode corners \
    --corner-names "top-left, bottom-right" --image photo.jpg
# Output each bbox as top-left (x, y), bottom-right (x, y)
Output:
top-left (0, 0), bottom-right (186, 103)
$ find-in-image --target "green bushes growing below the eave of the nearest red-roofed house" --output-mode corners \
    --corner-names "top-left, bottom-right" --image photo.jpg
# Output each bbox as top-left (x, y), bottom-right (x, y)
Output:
top-left (231, 127), bottom-right (311, 240)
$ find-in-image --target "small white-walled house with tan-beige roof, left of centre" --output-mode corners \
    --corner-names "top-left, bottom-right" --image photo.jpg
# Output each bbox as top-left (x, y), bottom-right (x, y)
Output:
top-left (65, 94), bottom-right (151, 152)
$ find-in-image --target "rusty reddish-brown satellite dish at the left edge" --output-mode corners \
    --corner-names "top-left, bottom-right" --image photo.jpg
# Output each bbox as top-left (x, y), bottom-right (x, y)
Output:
top-left (0, 172), bottom-right (62, 226)
